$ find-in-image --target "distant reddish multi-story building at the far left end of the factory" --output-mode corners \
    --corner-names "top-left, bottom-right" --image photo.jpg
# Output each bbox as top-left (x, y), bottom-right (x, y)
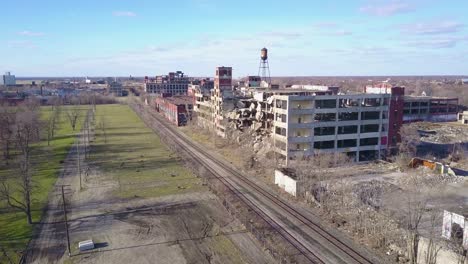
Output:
top-left (145, 71), bottom-right (190, 95)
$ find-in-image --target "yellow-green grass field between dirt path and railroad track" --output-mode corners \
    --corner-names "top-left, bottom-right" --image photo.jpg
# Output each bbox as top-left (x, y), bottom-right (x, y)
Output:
top-left (91, 105), bottom-right (203, 198)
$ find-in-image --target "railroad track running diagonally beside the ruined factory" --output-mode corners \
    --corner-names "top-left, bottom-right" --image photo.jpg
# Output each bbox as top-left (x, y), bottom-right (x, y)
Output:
top-left (134, 103), bottom-right (378, 264)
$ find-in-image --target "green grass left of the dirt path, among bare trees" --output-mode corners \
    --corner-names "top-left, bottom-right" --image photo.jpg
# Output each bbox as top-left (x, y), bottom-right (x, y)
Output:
top-left (0, 104), bottom-right (86, 263)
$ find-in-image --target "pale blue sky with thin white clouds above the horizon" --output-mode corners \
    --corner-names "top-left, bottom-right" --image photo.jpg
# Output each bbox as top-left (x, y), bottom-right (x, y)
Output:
top-left (0, 0), bottom-right (468, 77)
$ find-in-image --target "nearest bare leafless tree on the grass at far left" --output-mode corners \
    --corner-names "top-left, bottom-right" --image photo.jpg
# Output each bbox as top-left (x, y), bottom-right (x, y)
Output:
top-left (0, 110), bottom-right (39, 224)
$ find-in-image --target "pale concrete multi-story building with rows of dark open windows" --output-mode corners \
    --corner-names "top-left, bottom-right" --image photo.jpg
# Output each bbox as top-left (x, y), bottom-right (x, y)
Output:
top-left (273, 91), bottom-right (391, 161)
